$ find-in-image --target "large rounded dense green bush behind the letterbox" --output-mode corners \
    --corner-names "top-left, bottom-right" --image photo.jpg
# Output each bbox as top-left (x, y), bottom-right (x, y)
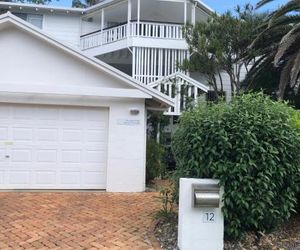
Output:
top-left (172, 93), bottom-right (300, 239)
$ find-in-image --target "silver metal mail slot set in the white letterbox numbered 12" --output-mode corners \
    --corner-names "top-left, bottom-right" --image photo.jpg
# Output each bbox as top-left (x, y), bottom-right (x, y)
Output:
top-left (192, 184), bottom-right (220, 208)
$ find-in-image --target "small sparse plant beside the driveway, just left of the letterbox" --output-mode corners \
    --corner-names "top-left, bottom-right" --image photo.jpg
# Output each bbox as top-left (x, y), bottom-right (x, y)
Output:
top-left (155, 187), bottom-right (176, 219)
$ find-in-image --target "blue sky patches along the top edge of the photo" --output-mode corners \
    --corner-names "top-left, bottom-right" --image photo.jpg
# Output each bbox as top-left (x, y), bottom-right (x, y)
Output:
top-left (51, 0), bottom-right (288, 13)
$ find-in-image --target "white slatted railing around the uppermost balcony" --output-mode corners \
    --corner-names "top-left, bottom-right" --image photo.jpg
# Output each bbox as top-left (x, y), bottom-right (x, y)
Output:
top-left (80, 22), bottom-right (183, 50)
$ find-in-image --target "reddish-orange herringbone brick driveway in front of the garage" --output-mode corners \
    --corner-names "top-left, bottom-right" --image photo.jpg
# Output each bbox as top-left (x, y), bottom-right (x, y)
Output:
top-left (0, 193), bottom-right (160, 250)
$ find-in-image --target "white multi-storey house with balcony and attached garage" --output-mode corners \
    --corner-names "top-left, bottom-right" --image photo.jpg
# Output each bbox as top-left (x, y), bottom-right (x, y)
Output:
top-left (0, 0), bottom-right (230, 191)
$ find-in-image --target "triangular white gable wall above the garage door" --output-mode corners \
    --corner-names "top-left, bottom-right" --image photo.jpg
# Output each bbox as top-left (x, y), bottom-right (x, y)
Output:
top-left (0, 25), bottom-right (129, 88)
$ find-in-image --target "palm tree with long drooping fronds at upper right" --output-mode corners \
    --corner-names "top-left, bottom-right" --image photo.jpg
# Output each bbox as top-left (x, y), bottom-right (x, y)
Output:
top-left (249, 0), bottom-right (300, 99)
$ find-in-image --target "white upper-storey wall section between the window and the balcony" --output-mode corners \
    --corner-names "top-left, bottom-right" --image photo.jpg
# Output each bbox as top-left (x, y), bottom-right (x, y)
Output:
top-left (43, 13), bottom-right (81, 47)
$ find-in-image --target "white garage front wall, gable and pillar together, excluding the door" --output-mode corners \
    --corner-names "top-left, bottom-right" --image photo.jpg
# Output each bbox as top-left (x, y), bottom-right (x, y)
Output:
top-left (0, 22), bottom-right (146, 192)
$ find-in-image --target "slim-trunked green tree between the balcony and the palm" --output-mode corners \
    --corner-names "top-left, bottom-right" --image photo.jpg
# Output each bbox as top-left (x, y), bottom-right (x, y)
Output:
top-left (183, 4), bottom-right (264, 96)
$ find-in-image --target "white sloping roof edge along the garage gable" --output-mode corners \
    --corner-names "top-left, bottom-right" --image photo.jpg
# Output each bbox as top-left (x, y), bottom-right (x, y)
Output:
top-left (0, 12), bottom-right (174, 106)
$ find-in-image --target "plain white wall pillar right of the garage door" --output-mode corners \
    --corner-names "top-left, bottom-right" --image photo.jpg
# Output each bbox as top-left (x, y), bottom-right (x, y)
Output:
top-left (107, 101), bottom-right (146, 192)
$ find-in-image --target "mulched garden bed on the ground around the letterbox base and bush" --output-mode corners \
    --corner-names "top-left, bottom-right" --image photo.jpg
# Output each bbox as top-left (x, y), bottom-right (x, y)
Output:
top-left (155, 215), bottom-right (300, 250)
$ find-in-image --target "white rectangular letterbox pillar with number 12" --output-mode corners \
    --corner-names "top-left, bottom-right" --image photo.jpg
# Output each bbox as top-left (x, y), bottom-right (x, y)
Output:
top-left (178, 178), bottom-right (224, 250)
